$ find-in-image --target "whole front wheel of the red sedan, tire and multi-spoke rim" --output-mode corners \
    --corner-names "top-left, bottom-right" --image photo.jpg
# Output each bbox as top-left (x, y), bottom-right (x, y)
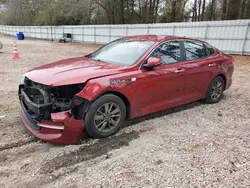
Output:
top-left (85, 94), bottom-right (126, 138)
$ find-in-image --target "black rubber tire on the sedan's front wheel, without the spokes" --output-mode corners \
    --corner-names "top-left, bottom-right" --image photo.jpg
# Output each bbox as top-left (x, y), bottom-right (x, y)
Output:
top-left (84, 94), bottom-right (126, 138)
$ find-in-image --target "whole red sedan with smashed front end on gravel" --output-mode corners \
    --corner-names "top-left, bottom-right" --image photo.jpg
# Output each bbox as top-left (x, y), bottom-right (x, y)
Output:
top-left (19, 35), bottom-right (234, 144)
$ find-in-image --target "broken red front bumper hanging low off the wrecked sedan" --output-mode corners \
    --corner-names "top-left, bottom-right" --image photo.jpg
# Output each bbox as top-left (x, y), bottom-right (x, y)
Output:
top-left (20, 102), bottom-right (84, 144)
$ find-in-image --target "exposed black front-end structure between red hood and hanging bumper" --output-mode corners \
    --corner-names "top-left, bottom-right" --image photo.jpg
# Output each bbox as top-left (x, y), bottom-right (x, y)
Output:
top-left (19, 77), bottom-right (84, 127)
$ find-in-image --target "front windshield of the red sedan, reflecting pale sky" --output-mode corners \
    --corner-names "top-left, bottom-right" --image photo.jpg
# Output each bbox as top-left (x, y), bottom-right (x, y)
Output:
top-left (89, 39), bottom-right (154, 66)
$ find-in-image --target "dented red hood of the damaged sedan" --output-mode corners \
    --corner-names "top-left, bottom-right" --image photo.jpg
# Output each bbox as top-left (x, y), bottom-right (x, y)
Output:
top-left (25, 57), bottom-right (126, 86)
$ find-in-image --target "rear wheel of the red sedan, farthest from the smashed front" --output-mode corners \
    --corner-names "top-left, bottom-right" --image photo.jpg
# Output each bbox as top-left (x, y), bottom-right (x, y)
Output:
top-left (205, 76), bottom-right (225, 104)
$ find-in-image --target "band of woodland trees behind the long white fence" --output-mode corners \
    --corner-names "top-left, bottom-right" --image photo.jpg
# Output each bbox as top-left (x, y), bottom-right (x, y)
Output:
top-left (0, 0), bottom-right (250, 25)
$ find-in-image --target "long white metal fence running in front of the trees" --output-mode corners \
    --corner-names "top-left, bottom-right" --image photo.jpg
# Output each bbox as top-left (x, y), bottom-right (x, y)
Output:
top-left (0, 20), bottom-right (250, 55)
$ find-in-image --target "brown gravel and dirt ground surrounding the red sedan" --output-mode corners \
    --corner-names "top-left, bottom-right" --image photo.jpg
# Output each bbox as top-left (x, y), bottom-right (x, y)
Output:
top-left (0, 35), bottom-right (250, 188)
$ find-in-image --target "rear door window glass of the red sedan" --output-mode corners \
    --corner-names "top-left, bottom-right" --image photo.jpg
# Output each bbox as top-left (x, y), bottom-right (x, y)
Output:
top-left (184, 41), bottom-right (208, 60)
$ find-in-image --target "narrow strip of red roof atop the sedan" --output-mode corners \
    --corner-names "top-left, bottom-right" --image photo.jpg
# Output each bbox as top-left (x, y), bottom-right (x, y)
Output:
top-left (122, 35), bottom-right (206, 43)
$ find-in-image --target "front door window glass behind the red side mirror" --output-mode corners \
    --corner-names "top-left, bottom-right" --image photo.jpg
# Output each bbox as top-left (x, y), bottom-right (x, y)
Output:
top-left (150, 41), bottom-right (181, 65)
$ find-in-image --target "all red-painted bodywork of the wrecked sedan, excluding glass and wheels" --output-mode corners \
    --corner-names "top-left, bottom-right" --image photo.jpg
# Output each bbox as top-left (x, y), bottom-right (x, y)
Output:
top-left (21, 35), bottom-right (233, 144)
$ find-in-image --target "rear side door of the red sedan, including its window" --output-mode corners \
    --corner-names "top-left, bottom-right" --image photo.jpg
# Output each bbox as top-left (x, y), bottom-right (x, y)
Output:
top-left (183, 40), bottom-right (220, 101)
